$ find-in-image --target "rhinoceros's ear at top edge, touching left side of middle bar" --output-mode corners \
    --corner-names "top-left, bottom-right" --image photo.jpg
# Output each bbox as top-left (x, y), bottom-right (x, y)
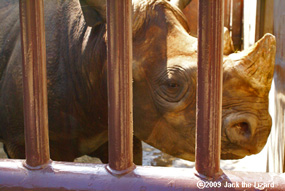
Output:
top-left (80, 0), bottom-right (106, 27)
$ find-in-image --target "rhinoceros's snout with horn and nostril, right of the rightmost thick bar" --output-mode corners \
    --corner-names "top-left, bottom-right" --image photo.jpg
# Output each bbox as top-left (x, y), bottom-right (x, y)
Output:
top-left (222, 34), bottom-right (276, 158)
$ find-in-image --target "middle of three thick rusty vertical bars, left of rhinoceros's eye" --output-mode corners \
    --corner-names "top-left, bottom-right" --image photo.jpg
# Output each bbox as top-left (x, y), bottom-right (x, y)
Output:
top-left (107, 0), bottom-right (134, 174)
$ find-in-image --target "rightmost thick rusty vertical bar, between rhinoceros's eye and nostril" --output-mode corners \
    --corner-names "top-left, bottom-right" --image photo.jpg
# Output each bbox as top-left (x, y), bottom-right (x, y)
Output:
top-left (195, 0), bottom-right (224, 178)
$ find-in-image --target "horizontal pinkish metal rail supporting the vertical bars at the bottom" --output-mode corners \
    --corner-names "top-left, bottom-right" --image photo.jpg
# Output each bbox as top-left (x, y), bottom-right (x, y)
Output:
top-left (0, 159), bottom-right (285, 191)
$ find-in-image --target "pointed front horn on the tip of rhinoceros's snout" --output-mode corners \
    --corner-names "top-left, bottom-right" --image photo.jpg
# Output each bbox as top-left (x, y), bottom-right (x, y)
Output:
top-left (229, 34), bottom-right (276, 95)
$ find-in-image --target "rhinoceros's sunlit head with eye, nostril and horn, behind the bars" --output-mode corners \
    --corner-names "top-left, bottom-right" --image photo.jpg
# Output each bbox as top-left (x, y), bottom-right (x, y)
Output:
top-left (79, 0), bottom-right (275, 160)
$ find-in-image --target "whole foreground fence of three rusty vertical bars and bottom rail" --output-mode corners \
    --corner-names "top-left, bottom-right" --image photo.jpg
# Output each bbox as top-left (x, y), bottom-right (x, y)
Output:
top-left (0, 0), bottom-right (285, 191)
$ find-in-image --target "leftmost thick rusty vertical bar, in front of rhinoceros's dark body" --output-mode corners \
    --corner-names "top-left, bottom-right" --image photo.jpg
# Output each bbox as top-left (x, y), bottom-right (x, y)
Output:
top-left (20, 0), bottom-right (50, 168)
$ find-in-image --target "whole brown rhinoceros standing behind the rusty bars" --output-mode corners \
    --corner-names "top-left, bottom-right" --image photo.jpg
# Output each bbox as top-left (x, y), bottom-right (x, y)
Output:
top-left (0, 0), bottom-right (275, 163)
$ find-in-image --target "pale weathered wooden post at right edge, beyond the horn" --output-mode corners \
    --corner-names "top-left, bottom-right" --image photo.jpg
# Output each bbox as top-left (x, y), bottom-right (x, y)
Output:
top-left (267, 0), bottom-right (285, 172)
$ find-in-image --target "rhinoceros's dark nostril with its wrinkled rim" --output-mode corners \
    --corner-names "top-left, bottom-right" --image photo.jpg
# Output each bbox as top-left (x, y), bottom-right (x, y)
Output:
top-left (224, 114), bottom-right (257, 148)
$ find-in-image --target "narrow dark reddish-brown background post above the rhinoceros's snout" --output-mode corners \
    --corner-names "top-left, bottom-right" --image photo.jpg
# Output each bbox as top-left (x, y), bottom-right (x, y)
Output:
top-left (232, 0), bottom-right (243, 50)
